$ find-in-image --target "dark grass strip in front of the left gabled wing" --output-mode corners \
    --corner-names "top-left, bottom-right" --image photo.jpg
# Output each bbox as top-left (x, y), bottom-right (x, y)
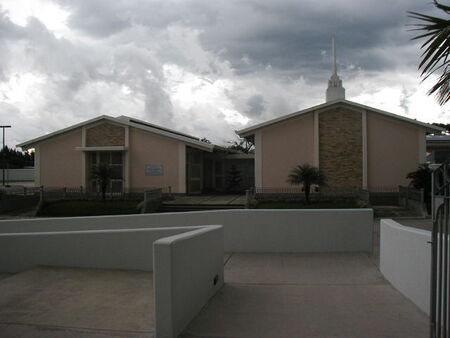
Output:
top-left (38, 200), bottom-right (139, 217)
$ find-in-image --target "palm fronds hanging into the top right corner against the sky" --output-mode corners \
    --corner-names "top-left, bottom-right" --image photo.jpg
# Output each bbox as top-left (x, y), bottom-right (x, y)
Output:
top-left (409, 0), bottom-right (450, 105)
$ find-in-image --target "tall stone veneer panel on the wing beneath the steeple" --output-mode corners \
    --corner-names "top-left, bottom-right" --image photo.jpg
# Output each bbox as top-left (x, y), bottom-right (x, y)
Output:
top-left (319, 108), bottom-right (362, 187)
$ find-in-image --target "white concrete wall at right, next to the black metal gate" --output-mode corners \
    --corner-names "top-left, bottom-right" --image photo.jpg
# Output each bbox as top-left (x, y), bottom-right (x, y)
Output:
top-left (380, 219), bottom-right (431, 314)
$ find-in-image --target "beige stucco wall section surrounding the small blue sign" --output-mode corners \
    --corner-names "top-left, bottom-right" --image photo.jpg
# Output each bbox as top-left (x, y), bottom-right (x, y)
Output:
top-left (129, 128), bottom-right (181, 193)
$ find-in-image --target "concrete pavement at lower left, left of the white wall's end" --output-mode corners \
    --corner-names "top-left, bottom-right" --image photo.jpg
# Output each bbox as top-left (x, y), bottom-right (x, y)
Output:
top-left (0, 267), bottom-right (154, 337)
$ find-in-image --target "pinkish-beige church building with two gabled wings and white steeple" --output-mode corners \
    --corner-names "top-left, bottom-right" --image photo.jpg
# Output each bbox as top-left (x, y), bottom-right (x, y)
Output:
top-left (18, 42), bottom-right (442, 194)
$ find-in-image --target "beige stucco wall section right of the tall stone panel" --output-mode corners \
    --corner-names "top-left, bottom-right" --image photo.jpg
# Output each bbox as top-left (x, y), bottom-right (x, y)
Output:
top-left (367, 112), bottom-right (425, 189)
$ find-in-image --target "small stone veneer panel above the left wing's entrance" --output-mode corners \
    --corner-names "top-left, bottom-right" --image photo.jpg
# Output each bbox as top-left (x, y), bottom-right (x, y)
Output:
top-left (86, 123), bottom-right (125, 147)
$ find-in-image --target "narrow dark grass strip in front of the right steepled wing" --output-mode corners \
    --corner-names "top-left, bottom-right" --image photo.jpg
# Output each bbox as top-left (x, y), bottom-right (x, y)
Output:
top-left (255, 199), bottom-right (367, 209)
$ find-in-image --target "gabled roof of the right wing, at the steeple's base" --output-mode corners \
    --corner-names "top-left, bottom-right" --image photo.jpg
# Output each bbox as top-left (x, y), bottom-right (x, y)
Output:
top-left (236, 100), bottom-right (444, 137)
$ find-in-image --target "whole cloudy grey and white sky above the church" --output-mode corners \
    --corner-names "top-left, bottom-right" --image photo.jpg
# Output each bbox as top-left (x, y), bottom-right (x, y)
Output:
top-left (0, 0), bottom-right (450, 146)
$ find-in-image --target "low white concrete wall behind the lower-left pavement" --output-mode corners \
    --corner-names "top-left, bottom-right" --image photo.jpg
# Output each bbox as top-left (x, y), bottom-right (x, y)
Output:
top-left (0, 227), bottom-right (206, 273)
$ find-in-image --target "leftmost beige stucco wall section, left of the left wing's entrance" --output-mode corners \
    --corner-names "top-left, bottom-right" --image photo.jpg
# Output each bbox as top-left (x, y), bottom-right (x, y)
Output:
top-left (39, 128), bottom-right (82, 187)
